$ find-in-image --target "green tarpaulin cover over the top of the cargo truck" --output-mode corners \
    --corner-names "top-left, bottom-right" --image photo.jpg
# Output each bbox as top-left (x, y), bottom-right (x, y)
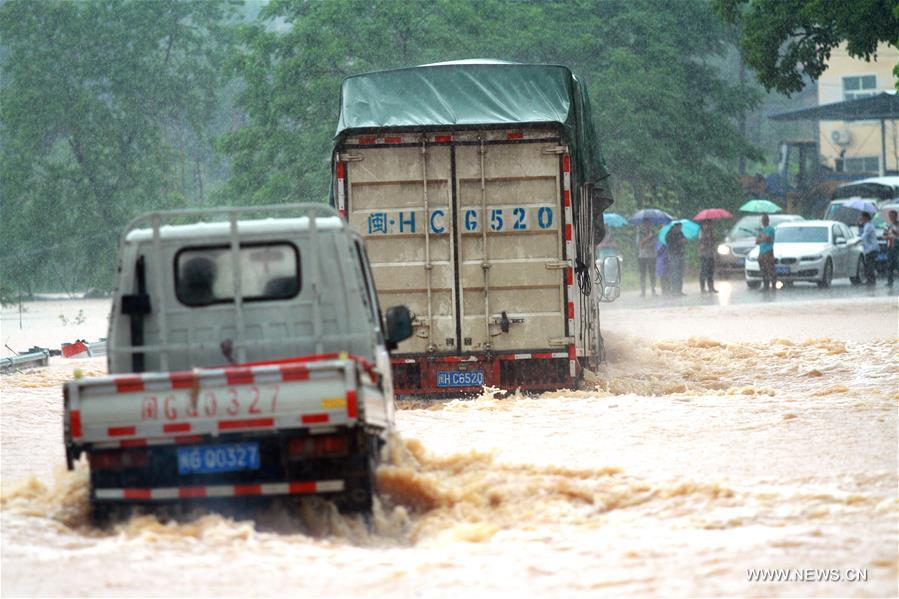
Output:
top-left (335, 60), bottom-right (611, 206)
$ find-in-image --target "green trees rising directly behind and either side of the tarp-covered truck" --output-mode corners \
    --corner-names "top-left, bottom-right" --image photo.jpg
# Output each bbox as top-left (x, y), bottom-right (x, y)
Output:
top-left (229, 0), bottom-right (758, 219)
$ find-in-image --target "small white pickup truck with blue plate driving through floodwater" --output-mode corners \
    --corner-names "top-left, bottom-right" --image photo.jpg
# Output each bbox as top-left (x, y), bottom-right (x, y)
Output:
top-left (64, 204), bottom-right (412, 521)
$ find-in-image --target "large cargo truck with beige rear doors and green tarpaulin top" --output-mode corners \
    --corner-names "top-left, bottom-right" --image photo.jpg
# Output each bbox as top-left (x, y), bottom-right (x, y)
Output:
top-left (331, 60), bottom-right (619, 396)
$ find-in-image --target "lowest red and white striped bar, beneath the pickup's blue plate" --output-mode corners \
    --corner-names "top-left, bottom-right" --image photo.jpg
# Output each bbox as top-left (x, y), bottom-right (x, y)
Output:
top-left (94, 480), bottom-right (344, 501)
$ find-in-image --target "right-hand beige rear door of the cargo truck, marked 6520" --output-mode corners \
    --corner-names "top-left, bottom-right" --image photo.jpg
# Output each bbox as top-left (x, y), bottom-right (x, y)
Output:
top-left (455, 135), bottom-right (566, 351)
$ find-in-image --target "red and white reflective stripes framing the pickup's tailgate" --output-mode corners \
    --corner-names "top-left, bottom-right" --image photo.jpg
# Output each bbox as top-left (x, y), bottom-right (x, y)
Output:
top-left (68, 353), bottom-right (376, 447)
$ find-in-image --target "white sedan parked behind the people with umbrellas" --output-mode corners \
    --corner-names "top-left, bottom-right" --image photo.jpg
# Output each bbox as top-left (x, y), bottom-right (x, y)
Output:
top-left (745, 220), bottom-right (865, 289)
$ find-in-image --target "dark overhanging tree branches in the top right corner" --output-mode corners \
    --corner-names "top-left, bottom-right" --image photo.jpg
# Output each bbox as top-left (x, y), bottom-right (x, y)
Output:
top-left (713, 0), bottom-right (899, 94)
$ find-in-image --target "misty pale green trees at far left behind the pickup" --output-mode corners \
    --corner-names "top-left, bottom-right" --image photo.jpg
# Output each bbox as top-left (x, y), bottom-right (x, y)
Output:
top-left (0, 0), bottom-right (241, 290)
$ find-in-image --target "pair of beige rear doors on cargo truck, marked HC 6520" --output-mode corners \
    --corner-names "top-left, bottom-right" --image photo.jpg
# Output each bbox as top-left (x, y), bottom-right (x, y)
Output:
top-left (338, 131), bottom-right (568, 353)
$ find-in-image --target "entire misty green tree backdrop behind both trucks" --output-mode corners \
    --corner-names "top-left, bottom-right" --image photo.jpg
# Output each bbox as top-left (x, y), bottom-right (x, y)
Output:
top-left (0, 0), bottom-right (758, 291)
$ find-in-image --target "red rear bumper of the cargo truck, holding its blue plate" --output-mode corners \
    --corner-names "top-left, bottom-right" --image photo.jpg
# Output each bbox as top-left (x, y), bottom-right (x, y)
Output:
top-left (391, 350), bottom-right (578, 397)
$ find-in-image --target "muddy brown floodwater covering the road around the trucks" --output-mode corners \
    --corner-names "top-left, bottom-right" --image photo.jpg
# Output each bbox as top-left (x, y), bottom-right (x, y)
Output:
top-left (0, 297), bottom-right (899, 597)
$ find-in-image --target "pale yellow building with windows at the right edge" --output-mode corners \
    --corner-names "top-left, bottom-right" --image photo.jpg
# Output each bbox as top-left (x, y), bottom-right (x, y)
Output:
top-left (818, 44), bottom-right (899, 176)
